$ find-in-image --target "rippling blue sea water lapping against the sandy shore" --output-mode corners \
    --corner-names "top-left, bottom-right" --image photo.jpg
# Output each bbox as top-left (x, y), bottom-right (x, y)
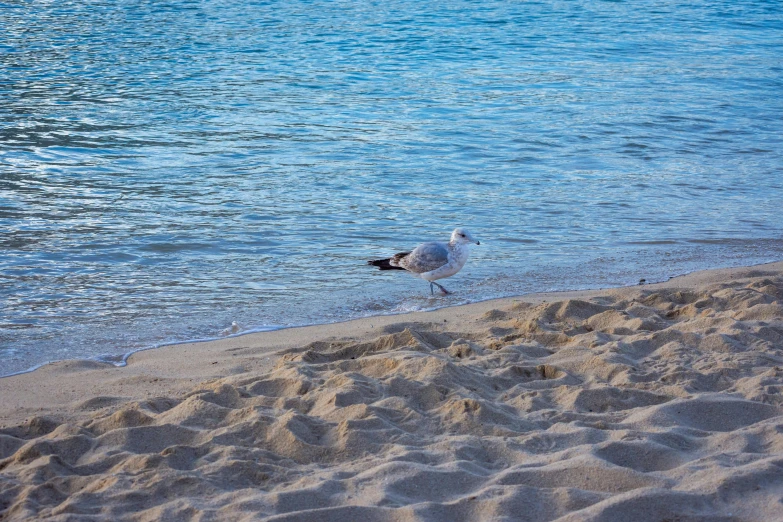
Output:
top-left (0, 0), bottom-right (783, 375)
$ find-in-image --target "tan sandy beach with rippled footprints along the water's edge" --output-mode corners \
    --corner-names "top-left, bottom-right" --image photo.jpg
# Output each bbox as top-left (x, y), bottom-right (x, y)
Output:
top-left (0, 263), bottom-right (783, 522)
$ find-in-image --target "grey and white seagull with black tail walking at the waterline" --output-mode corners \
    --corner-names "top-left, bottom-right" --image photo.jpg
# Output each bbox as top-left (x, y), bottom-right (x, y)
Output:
top-left (367, 228), bottom-right (481, 294)
